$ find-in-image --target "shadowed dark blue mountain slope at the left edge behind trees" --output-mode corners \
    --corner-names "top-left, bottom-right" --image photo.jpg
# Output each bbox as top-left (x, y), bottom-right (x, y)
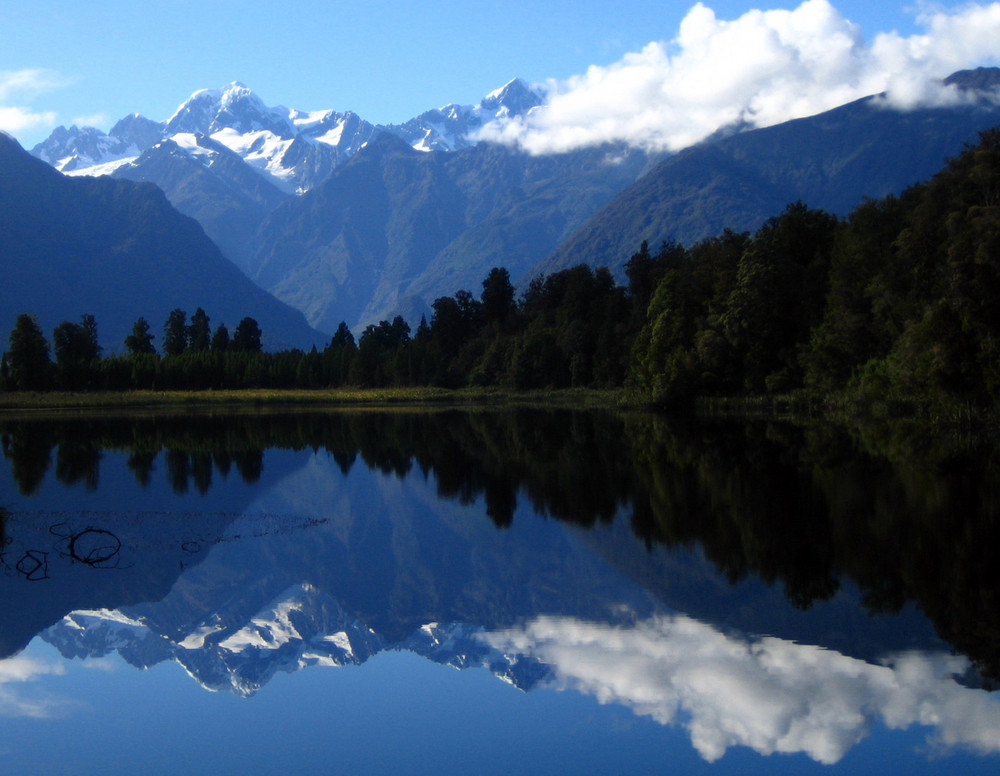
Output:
top-left (0, 134), bottom-right (324, 352)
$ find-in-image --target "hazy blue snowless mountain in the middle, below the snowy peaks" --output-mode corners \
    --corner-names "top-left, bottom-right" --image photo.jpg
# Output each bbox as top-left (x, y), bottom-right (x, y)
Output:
top-left (249, 133), bottom-right (648, 331)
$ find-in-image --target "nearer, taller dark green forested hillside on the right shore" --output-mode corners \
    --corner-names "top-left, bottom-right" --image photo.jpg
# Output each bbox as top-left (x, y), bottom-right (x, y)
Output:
top-left (631, 128), bottom-right (1000, 409)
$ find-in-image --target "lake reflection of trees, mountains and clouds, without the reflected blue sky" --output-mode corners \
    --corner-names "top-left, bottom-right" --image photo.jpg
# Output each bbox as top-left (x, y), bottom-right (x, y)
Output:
top-left (0, 410), bottom-right (1000, 763)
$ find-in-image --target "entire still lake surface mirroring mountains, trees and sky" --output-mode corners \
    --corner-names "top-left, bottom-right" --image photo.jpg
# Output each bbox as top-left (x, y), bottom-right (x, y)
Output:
top-left (0, 410), bottom-right (1000, 774)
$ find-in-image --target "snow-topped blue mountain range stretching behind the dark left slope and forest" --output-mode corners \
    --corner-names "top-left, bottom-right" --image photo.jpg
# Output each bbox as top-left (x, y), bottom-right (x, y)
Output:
top-left (13, 68), bottom-right (1000, 345)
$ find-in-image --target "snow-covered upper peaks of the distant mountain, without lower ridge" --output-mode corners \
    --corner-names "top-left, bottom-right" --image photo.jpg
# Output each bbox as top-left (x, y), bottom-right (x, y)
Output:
top-left (32, 79), bottom-right (542, 194)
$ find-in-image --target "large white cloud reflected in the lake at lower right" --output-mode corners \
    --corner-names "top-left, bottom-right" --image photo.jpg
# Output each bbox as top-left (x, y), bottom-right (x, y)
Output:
top-left (485, 616), bottom-right (1000, 764)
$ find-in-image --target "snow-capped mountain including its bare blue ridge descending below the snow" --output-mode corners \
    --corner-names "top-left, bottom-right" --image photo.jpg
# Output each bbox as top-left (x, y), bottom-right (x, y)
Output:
top-left (32, 79), bottom-right (542, 278)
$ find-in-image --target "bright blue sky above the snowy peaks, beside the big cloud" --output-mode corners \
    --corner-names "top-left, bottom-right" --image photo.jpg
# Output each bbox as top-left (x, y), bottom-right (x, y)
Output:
top-left (0, 0), bottom-right (1000, 147)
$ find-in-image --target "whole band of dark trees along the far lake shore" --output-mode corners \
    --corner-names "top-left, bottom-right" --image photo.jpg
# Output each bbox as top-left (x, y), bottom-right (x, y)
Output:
top-left (0, 128), bottom-right (1000, 412)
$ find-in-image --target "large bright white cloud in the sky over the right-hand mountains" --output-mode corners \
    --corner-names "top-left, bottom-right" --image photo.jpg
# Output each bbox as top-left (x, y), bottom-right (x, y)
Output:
top-left (479, 0), bottom-right (1000, 153)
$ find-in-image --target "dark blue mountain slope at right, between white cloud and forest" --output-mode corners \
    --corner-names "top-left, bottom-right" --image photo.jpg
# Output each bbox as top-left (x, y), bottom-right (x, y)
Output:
top-left (533, 68), bottom-right (1000, 279)
